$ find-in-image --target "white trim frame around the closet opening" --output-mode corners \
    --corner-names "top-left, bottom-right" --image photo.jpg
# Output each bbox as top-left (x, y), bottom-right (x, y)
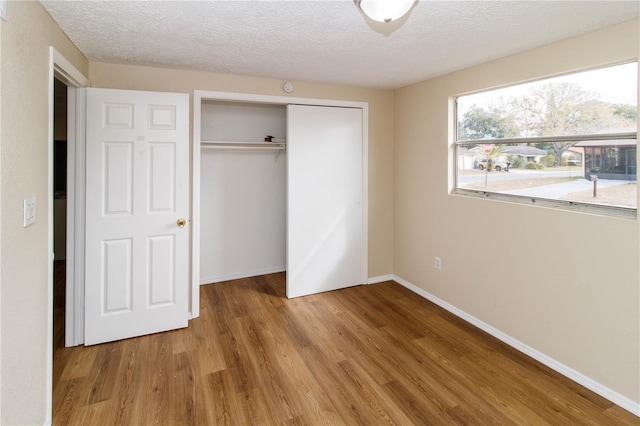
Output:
top-left (191, 90), bottom-right (369, 302)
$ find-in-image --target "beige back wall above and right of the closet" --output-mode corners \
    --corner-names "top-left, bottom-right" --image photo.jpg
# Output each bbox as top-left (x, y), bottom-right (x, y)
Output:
top-left (89, 62), bottom-right (393, 277)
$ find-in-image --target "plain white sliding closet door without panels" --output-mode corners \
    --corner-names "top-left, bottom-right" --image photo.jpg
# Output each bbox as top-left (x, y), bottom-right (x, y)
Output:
top-left (287, 105), bottom-right (365, 298)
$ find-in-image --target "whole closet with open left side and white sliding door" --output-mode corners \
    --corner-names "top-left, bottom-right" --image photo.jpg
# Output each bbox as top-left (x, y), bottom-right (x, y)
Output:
top-left (192, 91), bottom-right (368, 297)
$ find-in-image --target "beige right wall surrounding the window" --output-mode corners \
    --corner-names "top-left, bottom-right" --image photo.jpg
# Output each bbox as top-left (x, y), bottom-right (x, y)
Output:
top-left (394, 21), bottom-right (640, 402)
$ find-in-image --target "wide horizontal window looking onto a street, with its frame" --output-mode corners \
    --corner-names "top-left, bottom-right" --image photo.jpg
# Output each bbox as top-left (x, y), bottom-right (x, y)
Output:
top-left (454, 62), bottom-right (638, 217)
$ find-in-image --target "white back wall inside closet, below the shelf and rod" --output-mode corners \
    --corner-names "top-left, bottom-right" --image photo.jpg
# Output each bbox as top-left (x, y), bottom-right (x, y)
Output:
top-left (200, 148), bottom-right (287, 284)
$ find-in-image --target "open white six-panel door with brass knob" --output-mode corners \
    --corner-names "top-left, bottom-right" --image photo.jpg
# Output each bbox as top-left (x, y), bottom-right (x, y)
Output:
top-left (84, 89), bottom-right (189, 345)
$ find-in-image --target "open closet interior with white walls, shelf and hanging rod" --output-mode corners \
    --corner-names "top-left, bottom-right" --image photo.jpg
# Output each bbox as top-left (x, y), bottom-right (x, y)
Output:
top-left (200, 100), bottom-right (287, 284)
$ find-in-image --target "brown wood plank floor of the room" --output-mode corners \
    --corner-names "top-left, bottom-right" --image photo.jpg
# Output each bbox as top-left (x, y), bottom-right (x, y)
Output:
top-left (53, 268), bottom-right (640, 425)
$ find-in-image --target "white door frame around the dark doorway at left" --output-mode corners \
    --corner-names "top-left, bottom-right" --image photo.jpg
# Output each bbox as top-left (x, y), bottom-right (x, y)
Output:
top-left (45, 46), bottom-right (89, 424)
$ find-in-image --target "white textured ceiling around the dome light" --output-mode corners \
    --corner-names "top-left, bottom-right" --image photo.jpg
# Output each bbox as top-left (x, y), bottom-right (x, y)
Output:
top-left (41, 0), bottom-right (640, 88)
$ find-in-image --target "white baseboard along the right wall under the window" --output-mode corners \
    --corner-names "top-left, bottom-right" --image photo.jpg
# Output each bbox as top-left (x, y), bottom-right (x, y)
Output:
top-left (392, 275), bottom-right (640, 416)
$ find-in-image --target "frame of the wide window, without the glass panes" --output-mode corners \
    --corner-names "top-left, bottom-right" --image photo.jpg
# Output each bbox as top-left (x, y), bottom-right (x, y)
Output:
top-left (450, 63), bottom-right (640, 220)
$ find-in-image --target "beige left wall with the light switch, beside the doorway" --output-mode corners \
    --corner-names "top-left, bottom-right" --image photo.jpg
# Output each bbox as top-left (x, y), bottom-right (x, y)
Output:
top-left (0, 1), bottom-right (88, 424)
